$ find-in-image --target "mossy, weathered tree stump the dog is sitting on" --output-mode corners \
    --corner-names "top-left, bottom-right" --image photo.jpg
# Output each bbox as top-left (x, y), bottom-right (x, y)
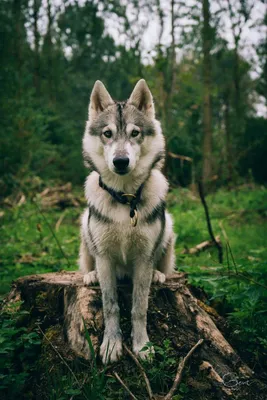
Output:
top-left (6, 272), bottom-right (267, 400)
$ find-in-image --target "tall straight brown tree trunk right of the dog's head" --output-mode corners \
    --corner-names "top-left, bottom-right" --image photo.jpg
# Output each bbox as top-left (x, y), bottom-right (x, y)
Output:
top-left (202, 0), bottom-right (212, 182)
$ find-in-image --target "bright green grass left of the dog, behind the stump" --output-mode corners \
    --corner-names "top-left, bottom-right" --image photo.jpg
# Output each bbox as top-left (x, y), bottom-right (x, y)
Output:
top-left (0, 203), bottom-right (81, 294)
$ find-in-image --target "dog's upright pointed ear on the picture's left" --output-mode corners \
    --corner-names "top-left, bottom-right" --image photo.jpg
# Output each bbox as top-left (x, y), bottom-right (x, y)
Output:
top-left (89, 81), bottom-right (114, 120)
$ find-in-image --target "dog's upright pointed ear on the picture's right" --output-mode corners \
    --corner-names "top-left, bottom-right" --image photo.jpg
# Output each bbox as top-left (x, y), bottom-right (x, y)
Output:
top-left (128, 79), bottom-right (155, 118)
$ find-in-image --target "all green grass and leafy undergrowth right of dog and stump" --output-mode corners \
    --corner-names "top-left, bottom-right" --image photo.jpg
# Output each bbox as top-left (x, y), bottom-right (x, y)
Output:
top-left (170, 185), bottom-right (267, 364)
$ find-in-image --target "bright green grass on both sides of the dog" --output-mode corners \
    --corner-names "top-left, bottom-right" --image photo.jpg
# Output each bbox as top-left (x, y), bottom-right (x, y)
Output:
top-left (0, 184), bottom-right (267, 294)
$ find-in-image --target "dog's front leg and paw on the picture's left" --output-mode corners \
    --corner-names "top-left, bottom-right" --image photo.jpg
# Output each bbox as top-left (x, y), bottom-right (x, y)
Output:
top-left (96, 257), bottom-right (122, 364)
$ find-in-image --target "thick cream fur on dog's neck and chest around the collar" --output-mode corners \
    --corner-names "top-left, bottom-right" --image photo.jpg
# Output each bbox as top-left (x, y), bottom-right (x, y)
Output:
top-left (83, 170), bottom-right (168, 268)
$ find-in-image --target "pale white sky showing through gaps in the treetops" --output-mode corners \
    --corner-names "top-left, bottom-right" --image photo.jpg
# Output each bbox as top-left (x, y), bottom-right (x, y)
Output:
top-left (28, 0), bottom-right (267, 116)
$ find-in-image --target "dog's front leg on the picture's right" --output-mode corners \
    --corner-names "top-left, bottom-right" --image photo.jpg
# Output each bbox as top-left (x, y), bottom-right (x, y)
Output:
top-left (132, 260), bottom-right (153, 358)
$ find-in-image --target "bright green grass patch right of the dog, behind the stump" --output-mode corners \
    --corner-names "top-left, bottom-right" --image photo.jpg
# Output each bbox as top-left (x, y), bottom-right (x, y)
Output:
top-left (169, 187), bottom-right (267, 295)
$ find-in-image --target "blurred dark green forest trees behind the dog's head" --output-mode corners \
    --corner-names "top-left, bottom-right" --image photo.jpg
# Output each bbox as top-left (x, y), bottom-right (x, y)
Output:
top-left (0, 0), bottom-right (267, 196)
